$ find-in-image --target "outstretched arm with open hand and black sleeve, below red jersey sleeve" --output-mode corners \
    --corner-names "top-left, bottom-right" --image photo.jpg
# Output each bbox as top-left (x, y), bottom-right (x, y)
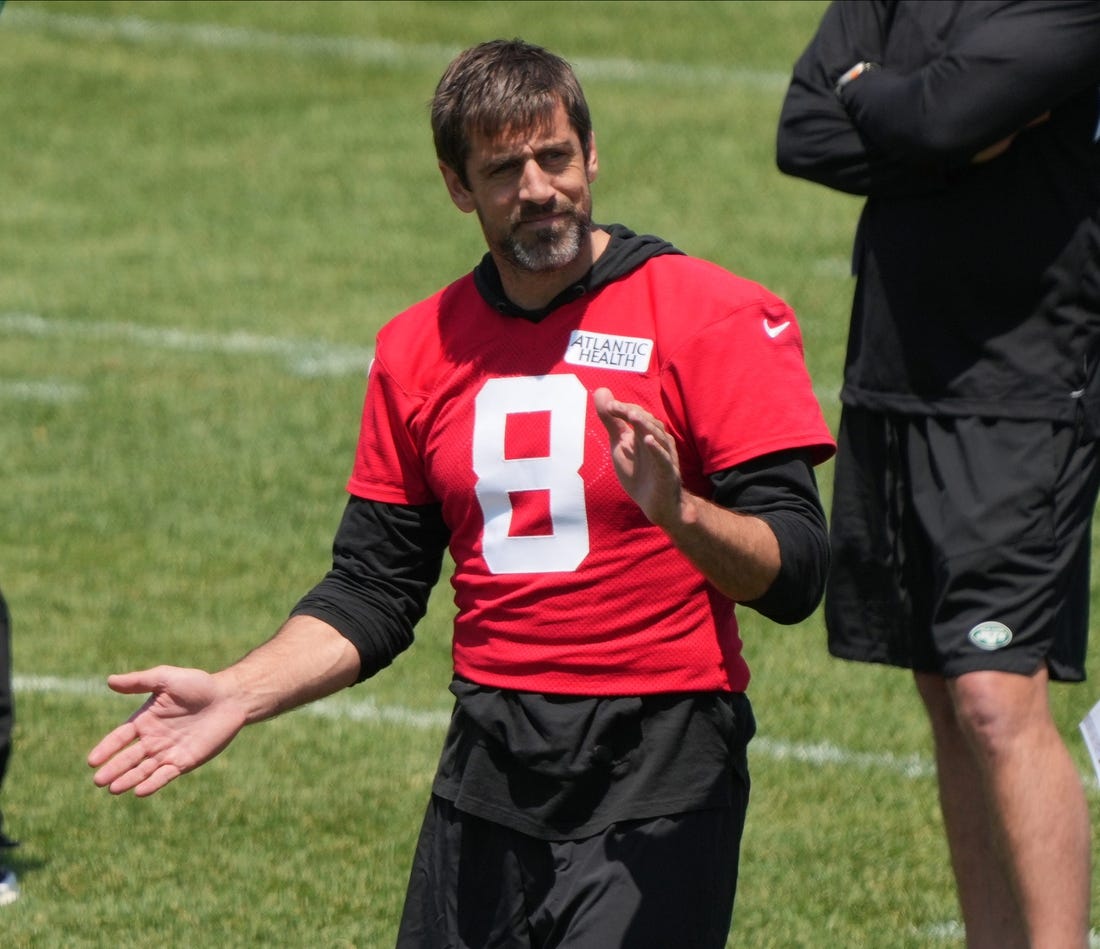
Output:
top-left (88, 498), bottom-right (433, 796)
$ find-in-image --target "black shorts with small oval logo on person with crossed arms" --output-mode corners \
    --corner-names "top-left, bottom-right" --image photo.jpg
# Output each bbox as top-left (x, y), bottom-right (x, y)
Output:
top-left (825, 407), bottom-right (1100, 682)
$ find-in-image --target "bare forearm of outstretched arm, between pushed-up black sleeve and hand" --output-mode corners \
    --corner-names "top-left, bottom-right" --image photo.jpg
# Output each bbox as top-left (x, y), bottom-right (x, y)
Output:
top-left (213, 616), bottom-right (360, 725)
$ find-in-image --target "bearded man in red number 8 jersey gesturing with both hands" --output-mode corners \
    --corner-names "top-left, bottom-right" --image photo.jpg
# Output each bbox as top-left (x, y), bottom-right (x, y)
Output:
top-left (89, 41), bottom-right (833, 949)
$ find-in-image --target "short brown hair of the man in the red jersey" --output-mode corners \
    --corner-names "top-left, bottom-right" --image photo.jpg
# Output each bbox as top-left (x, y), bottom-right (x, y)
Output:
top-left (431, 40), bottom-right (592, 185)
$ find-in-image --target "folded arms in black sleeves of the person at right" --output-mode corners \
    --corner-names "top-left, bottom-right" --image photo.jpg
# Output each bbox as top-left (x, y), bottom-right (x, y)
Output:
top-left (776, 0), bottom-right (1100, 196)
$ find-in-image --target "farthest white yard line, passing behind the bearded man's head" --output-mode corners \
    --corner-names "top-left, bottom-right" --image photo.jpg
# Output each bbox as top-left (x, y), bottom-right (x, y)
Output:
top-left (0, 7), bottom-right (790, 92)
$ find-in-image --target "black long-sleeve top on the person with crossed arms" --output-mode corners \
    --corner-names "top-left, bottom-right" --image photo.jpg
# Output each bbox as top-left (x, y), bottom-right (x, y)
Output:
top-left (777, 0), bottom-right (1100, 430)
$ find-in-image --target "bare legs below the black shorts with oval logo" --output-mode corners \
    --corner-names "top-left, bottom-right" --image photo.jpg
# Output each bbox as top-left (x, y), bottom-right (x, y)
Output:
top-left (916, 669), bottom-right (1090, 949)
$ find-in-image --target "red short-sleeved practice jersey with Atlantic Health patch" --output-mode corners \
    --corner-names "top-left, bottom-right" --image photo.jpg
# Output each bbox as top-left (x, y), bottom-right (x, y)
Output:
top-left (349, 255), bottom-right (833, 695)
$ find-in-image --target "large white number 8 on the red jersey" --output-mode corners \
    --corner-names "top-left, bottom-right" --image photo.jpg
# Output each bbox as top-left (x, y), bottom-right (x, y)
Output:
top-left (473, 375), bottom-right (589, 573)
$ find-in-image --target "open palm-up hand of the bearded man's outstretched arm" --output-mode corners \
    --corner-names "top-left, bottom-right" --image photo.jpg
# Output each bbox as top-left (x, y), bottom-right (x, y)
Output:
top-left (88, 665), bottom-right (245, 797)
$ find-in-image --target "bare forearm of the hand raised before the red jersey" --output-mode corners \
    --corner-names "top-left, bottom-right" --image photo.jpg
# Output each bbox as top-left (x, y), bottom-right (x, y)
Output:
top-left (660, 490), bottom-right (781, 603)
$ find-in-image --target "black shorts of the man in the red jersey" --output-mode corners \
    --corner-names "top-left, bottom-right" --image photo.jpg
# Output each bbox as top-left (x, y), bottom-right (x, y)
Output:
top-left (397, 795), bottom-right (747, 949)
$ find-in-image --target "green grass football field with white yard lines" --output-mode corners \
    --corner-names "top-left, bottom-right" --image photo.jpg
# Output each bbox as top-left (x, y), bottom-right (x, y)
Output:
top-left (0, 0), bottom-right (1100, 949)
